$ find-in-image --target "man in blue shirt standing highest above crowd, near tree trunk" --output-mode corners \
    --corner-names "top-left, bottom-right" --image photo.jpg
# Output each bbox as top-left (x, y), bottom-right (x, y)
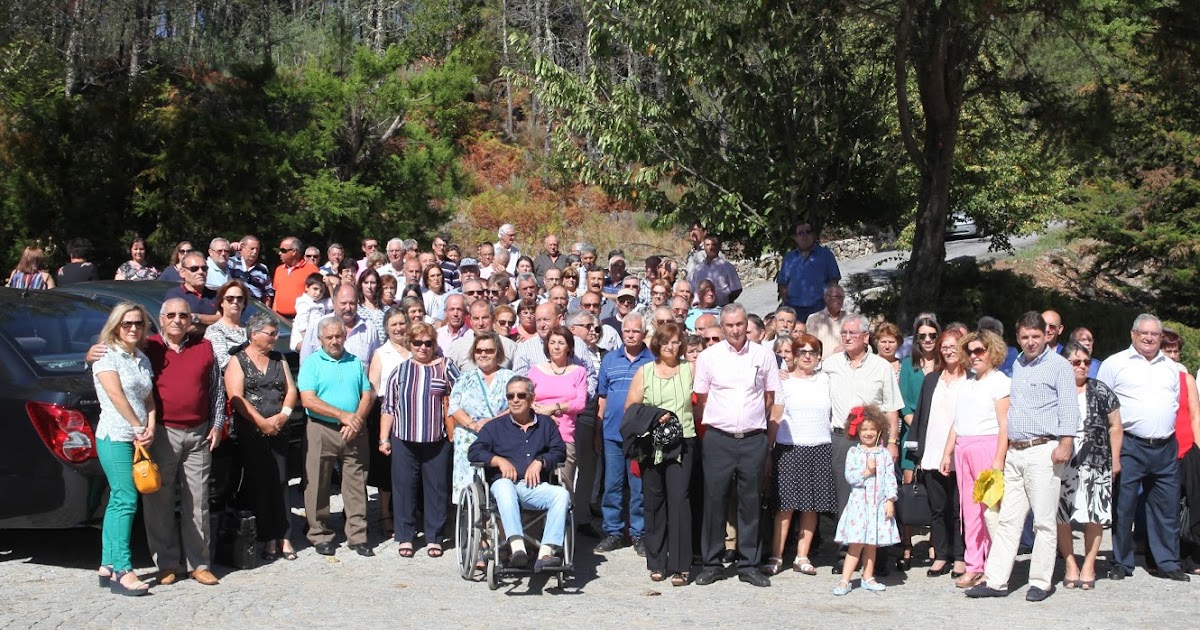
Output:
top-left (775, 221), bottom-right (841, 322)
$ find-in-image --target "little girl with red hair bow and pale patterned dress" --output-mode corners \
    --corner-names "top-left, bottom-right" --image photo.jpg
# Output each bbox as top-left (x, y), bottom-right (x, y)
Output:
top-left (833, 404), bottom-right (900, 595)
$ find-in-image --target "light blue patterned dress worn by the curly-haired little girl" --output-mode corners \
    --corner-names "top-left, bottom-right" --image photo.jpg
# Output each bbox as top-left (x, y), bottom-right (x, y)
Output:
top-left (834, 444), bottom-right (900, 547)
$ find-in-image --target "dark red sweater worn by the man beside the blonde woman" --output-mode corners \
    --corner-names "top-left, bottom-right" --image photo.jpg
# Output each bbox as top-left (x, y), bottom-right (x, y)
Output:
top-left (145, 335), bottom-right (223, 428)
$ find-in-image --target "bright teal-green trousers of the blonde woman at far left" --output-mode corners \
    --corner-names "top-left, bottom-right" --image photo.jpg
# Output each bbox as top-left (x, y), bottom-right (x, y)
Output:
top-left (96, 438), bottom-right (138, 571)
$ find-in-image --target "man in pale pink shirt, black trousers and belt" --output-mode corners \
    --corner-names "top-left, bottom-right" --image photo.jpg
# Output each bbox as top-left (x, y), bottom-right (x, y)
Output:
top-left (694, 304), bottom-right (779, 587)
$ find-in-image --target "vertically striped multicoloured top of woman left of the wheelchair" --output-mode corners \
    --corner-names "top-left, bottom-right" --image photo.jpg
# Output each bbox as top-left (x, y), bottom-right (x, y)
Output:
top-left (383, 359), bottom-right (458, 443)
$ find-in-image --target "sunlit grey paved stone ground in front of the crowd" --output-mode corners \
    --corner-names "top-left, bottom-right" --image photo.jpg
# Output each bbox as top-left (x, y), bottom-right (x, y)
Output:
top-left (0, 489), bottom-right (1200, 629)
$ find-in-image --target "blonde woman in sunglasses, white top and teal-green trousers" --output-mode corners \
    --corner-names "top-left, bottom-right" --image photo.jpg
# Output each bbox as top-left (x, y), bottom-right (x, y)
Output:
top-left (91, 302), bottom-right (158, 595)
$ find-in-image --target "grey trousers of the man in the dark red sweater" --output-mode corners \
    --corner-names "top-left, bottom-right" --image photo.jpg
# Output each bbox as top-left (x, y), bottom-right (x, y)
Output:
top-left (142, 422), bottom-right (212, 571)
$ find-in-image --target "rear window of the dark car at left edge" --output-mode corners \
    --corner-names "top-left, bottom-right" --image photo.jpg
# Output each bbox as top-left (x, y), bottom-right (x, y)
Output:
top-left (0, 300), bottom-right (108, 374)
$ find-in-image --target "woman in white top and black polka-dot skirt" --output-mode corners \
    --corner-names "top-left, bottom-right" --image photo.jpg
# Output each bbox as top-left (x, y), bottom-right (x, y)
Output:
top-left (763, 335), bottom-right (838, 575)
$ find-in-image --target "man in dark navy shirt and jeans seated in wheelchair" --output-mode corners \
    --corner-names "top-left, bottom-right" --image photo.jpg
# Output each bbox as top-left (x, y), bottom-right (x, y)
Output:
top-left (467, 377), bottom-right (571, 571)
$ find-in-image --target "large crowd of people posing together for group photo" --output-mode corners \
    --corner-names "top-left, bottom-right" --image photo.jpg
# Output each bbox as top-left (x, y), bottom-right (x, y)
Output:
top-left (10, 222), bottom-right (1200, 601)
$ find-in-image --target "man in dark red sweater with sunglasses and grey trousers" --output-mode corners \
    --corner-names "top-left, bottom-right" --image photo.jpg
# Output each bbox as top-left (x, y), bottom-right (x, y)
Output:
top-left (143, 299), bottom-right (227, 586)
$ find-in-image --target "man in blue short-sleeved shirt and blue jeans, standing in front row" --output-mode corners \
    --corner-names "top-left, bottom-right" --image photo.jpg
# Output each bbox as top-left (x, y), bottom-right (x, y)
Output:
top-left (596, 313), bottom-right (654, 556)
